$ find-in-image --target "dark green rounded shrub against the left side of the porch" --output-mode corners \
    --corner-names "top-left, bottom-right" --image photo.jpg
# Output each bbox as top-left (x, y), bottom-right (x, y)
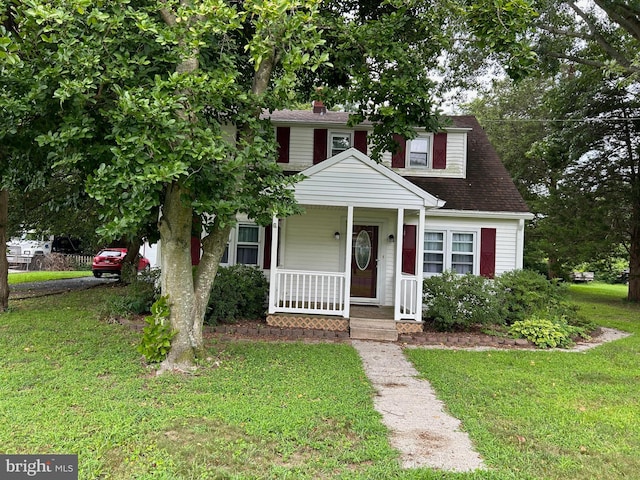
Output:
top-left (205, 265), bottom-right (269, 325)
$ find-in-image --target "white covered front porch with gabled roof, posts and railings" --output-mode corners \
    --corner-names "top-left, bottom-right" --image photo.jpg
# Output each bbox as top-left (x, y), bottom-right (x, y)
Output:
top-left (268, 149), bottom-right (444, 323)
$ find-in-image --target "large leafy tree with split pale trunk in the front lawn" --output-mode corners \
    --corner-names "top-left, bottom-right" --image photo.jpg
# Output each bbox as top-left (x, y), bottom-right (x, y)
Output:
top-left (0, 0), bottom-right (530, 369)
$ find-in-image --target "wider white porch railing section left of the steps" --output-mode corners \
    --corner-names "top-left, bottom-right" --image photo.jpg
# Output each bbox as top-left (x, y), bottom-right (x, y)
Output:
top-left (275, 270), bottom-right (345, 315)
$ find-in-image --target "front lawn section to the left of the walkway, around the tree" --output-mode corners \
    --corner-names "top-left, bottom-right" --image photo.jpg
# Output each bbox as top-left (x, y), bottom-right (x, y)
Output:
top-left (0, 287), bottom-right (396, 479)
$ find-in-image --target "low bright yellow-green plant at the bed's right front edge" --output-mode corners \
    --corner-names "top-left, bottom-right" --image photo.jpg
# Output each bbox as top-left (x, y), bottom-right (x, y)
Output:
top-left (509, 313), bottom-right (589, 348)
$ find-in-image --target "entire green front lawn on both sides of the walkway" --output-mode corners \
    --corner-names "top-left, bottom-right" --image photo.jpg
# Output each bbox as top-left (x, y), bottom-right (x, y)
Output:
top-left (0, 285), bottom-right (640, 480)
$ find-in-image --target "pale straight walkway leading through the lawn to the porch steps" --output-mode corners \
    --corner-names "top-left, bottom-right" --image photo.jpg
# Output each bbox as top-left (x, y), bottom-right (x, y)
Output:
top-left (351, 340), bottom-right (484, 472)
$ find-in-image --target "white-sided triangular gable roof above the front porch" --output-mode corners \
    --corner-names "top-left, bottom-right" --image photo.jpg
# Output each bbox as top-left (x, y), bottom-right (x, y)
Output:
top-left (295, 148), bottom-right (445, 209)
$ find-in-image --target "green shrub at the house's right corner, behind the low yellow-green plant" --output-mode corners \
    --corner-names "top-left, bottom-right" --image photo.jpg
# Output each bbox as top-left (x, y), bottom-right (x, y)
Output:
top-left (496, 270), bottom-right (571, 325)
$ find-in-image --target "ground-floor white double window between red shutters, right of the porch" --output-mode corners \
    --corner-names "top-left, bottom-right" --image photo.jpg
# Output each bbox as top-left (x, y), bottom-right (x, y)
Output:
top-left (423, 230), bottom-right (478, 276)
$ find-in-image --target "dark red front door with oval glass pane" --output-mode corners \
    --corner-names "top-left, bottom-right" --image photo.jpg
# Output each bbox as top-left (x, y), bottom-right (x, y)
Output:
top-left (351, 225), bottom-right (378, 298)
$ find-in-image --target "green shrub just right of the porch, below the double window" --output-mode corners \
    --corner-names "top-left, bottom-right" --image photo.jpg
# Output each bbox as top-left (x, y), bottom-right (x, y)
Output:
top-left (423, 272), bottom-right (502, 331)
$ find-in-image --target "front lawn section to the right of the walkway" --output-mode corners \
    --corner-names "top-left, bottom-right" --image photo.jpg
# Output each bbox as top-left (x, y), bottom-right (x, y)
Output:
top-left (408, 284), bottom-right (640, 480)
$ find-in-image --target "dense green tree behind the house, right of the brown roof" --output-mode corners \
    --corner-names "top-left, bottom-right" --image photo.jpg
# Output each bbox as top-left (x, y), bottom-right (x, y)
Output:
top-left (469, 68), bottom-right (638, 284)
